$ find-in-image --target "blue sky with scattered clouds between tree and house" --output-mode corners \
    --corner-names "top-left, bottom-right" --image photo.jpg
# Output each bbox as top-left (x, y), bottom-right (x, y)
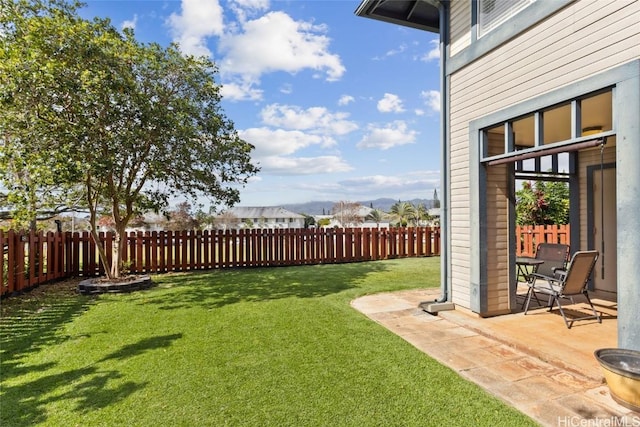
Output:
top-left (81, 0), bottom-right (440, 206)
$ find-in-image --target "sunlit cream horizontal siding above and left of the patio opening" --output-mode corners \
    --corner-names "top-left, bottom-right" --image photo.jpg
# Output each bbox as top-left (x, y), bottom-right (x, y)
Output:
top-left (450, 0), bottom-right (640, 314)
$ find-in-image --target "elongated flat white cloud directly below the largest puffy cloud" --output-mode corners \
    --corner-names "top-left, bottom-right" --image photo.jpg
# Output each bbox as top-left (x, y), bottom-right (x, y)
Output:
top-left (260, 104), bottom-right (358, 135)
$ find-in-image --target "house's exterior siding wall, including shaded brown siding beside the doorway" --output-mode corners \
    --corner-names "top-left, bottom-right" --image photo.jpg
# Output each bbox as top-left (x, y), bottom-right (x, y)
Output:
top-left (446, 0), bottom-right (640, 315)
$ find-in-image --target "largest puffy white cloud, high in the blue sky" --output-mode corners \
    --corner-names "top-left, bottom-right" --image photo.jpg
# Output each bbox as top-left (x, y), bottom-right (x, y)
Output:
top-left (219, 12), bottom-right (345, 81)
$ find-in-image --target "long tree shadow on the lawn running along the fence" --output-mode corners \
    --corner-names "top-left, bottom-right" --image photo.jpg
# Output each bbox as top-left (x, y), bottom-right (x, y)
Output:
top-left (144, 262), bottom-right (387, 310)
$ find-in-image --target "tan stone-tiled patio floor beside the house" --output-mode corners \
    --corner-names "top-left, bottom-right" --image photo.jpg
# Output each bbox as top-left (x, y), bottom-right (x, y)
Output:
top-left (352, 289), bottom-right (640, 426)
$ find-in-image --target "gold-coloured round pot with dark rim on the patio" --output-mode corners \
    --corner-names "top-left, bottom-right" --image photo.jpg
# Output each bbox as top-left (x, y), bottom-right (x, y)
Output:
top-left (594, 348), bottom-right (640, 412)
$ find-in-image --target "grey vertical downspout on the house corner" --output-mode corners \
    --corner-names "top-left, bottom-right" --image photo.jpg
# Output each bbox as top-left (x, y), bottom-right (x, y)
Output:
top-left (419, 1), bottom-right (455, 313)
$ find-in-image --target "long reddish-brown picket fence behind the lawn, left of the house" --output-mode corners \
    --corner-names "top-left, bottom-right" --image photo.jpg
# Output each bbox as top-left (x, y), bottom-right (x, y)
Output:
top-left (0, 227), bottom-right (440, 295)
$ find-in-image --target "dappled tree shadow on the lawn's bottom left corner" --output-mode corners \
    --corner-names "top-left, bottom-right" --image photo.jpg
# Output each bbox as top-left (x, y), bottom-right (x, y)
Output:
top-left (0, 334), bottom-right (182, 426)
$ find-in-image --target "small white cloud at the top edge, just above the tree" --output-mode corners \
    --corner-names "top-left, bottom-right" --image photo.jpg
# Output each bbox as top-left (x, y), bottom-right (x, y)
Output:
top-left (167, 0), bottom-right (224, 57)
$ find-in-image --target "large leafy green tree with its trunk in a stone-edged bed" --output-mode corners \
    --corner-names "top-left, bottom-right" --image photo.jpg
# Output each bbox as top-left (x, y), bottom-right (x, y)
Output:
top-left (0, 0), bottom-right (258, 278)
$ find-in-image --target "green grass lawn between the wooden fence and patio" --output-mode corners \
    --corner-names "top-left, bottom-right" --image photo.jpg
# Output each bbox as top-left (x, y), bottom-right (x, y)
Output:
top-left (0, 258), bottom-right (536, 427)
